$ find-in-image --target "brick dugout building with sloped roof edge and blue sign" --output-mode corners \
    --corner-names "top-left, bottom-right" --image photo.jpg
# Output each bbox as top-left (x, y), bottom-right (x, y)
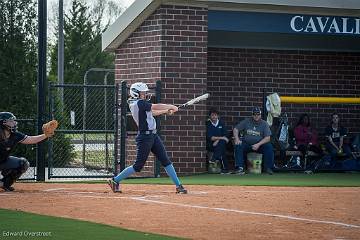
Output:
top-left (102, 0), bottom-right (360, 174)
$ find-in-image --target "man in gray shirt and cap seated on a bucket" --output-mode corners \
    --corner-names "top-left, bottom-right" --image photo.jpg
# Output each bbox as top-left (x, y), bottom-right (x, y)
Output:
top-left (233, 107), bottom-right (274, 174)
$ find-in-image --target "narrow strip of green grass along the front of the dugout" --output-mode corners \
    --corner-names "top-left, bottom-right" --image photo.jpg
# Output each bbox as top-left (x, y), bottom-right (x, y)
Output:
top-left (119, 173), bottom-right (360, 187)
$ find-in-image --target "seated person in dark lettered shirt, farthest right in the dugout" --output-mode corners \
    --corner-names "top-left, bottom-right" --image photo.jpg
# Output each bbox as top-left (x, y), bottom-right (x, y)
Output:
top-left (325, 113), bottom-right (353, 164)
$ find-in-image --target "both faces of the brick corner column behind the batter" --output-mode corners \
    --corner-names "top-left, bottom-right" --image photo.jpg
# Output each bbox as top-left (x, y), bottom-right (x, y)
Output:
top-left (115, 6), bottom-right (207, 174)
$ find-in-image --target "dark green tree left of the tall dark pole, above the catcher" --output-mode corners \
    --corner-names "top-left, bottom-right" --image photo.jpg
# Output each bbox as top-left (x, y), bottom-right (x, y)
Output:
top-left (0, 0), bottom-right (37, 118)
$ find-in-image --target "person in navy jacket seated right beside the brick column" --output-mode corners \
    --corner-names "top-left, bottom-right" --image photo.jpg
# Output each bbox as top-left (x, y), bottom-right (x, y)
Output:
top-left (207, 109), bottom-right (229, 174)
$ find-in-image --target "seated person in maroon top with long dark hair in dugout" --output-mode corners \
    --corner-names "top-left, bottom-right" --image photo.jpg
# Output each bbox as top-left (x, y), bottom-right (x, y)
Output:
top-left (294, 113), bottom-right (322, 159)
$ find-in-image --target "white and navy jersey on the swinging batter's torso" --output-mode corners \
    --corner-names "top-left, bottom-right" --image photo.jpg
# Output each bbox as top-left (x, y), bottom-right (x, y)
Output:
top-left (129, 99), bottom-right (156, 132)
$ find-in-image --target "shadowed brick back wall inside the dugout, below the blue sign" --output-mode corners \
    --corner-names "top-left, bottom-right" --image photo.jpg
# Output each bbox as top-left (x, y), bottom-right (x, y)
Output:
top-left (208, 48), bottom-right (360, 143)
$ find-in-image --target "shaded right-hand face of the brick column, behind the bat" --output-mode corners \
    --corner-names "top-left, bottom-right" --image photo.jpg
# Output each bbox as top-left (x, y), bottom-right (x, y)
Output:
top-left (160, 6), bottom-right (207, 174)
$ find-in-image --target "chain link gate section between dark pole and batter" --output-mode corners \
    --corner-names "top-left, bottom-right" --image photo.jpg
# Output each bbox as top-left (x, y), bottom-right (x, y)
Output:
top-left (48, 84), bottom-right (116, 178)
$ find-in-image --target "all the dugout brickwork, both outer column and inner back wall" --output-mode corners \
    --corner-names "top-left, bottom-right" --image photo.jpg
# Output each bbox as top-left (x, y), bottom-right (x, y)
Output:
top-left (115, 5), bottom-right (360, 176)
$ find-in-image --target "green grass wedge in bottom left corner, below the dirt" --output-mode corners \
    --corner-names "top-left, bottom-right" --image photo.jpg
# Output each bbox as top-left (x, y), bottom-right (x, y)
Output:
top-left (0, 209), bottom-right (184, 240)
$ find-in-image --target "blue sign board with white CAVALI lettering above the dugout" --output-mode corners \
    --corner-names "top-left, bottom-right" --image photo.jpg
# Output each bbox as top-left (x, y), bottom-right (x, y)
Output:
top-left (208, 10), bottom-right (360, 37)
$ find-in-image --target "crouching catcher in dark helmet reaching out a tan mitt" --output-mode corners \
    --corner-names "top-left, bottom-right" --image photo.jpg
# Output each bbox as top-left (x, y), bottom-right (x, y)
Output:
top-left (0, 112), bottom-right (58, 191)
